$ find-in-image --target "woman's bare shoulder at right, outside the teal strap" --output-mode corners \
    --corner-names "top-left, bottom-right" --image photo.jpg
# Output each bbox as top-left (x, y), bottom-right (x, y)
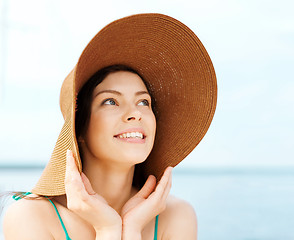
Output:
top-left (160, 195), bottom-right (197, 240)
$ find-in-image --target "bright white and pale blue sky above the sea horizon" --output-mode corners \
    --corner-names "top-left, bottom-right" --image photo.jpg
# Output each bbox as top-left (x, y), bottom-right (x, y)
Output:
top-left (0, 0), bottom-right (294, 168)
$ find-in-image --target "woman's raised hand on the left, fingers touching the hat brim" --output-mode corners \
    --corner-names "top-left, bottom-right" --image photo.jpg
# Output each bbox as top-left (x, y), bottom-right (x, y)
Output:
top-left (65, 150), bottom-right (122, 239)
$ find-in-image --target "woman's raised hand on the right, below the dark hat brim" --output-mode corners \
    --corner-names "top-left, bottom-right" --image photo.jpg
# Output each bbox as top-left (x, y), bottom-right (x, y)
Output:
top-left (121, 167), bottom-right (172, 239)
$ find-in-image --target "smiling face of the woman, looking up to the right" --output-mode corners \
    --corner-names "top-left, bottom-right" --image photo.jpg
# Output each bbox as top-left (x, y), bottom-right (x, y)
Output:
top-left (81, 71), bottom-right (156, 164)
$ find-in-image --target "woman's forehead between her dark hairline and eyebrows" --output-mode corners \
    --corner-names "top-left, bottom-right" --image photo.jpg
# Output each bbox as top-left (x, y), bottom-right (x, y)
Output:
top-left (94, 71), bottom-right (147, 94)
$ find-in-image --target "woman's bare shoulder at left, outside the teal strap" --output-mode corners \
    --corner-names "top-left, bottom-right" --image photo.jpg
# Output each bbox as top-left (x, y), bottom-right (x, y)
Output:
top-left (3, 196), bottom-right (53, 240)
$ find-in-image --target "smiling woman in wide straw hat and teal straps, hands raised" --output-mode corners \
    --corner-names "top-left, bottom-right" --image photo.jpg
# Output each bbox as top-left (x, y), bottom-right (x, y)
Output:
top-left (4, 14), bottom-right (216, 240)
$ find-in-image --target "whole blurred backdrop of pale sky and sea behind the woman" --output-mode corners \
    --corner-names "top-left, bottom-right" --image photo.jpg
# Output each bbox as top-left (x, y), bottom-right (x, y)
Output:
top-left (0, 0), bottom-right (294, 240)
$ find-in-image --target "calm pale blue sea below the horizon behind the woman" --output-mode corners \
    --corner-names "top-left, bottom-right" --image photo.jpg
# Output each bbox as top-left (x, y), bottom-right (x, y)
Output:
top-left (0, 167), bottom-right (294, 240)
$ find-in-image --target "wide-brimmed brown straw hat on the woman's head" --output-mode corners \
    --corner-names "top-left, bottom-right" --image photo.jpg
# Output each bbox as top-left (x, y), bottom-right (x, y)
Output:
top-left (32, 14), bottom-right (217, 196)
